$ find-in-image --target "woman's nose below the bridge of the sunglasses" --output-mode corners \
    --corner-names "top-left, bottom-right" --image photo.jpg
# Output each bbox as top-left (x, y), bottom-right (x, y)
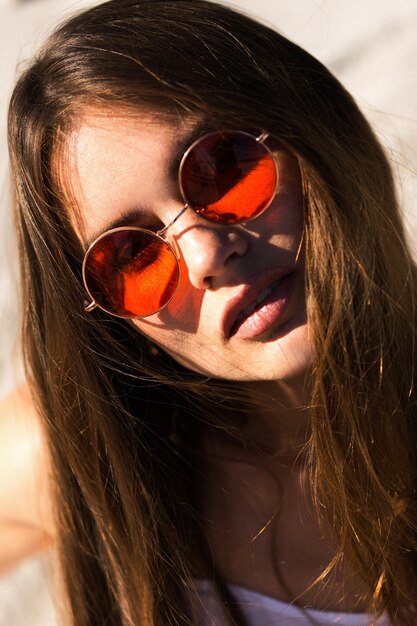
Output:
top-left (174, 209), bottom-right (249, 289)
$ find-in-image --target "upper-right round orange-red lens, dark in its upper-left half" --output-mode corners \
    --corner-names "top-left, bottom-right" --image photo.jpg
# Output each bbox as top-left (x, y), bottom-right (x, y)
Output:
top-left (180, 131), bottom-right (277, 224)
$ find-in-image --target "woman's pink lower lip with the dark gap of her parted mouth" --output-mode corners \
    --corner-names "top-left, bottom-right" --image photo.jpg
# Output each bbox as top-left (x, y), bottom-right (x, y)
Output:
top-left (230, 272), bottom-right (295, 339)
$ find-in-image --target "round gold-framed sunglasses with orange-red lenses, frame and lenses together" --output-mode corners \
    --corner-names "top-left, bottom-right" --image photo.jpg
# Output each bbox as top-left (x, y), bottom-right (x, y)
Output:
top-left (82, 130), bottom-right (278, 318)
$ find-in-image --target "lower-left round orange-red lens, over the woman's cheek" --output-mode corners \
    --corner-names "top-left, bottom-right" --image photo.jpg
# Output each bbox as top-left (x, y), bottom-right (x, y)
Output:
top-left (84, 228), bottom-right (179, 317)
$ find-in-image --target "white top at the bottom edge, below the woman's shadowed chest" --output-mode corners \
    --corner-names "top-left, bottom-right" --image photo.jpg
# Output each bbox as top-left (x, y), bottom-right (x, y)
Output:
top-left (193, 579), bottom-right (392, 626)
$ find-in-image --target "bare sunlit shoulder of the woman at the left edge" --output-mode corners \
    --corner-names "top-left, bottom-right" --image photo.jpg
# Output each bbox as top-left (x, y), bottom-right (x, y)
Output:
top-left (0, 384), bottom-right (54, 572)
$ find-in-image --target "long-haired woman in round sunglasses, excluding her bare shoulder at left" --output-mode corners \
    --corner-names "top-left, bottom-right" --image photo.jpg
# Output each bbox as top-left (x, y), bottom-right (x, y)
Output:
top-left (6, 0), bottom-right (417, 626)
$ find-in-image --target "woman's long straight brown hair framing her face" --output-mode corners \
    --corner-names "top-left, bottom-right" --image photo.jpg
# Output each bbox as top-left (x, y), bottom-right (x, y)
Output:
top-left (9, 0), bottom-right (417, 626)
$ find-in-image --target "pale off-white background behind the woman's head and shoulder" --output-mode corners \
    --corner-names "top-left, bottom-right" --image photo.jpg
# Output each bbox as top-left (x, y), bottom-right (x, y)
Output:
top-left (0, 0), bottom-right (417, 626)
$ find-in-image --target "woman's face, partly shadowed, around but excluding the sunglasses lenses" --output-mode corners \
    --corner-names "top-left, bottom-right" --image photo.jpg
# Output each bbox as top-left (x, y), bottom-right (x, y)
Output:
top-left (64, 112), bottom-right (311, 381)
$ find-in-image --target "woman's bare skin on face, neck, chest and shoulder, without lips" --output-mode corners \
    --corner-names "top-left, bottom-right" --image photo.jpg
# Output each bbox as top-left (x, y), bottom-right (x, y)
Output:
top-left (0, 112), bottom-right (366, 611)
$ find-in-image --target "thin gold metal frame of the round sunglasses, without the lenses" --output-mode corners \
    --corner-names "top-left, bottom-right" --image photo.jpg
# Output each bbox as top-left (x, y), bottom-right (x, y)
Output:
top-left (82, 130), bottom-right (278, 319)
